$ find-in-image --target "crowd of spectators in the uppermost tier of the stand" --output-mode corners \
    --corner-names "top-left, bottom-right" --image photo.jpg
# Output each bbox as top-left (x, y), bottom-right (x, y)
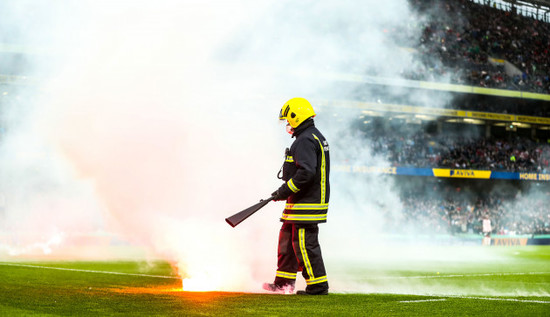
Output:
top-left (404, 0), bottom-right (550, 94)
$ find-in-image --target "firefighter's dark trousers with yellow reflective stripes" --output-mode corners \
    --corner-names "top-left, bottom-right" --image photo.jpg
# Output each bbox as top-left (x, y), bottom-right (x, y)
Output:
top-left (275, 222), bottom-right (328, 293)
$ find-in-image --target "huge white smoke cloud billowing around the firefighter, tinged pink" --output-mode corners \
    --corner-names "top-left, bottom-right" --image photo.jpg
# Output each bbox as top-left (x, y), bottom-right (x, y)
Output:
top-left (0, 0), bottom-right (520, 291)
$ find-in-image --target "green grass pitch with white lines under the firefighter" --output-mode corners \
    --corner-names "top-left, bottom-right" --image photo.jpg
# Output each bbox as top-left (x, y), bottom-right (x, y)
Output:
top-left (0, 247), bottom-right (550, 316)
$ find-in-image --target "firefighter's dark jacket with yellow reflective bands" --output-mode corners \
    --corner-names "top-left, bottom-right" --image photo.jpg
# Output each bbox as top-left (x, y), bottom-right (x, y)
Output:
top-left (279, 119), bottom-right (330, 223)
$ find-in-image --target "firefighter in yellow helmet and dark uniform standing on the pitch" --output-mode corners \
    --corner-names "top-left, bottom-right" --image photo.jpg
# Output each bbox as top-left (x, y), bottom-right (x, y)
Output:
top-left (263, 98), bottom-right (330, 295)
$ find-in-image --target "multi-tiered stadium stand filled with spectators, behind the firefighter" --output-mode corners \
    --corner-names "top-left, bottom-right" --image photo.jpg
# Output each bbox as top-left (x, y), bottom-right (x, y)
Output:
top-left (328, 0), bottom-right (550, 237)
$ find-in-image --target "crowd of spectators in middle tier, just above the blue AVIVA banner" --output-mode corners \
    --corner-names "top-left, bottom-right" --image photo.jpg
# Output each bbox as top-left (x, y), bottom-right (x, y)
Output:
top-left (371, 133), bottom-right (550, 173)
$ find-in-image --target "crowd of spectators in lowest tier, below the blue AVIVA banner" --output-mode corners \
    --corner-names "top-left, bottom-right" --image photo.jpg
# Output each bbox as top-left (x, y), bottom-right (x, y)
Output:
top-left (399, 187), bottom-right (550, 235)
